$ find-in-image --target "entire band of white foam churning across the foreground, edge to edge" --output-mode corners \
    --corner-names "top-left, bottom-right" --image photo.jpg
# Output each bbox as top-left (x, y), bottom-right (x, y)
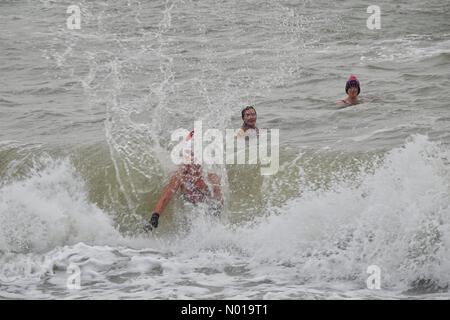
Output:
top-left (0, 136), bottom-right (450, 299)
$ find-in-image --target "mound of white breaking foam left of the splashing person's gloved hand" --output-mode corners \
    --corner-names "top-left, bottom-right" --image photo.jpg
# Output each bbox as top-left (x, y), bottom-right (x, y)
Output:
top-left (0, 156), bottom-right (120, 252)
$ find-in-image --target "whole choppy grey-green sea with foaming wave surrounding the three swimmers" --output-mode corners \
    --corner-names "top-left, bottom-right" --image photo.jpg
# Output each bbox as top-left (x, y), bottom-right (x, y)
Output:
top-left (0, 0), bottom-right (450, 299)
